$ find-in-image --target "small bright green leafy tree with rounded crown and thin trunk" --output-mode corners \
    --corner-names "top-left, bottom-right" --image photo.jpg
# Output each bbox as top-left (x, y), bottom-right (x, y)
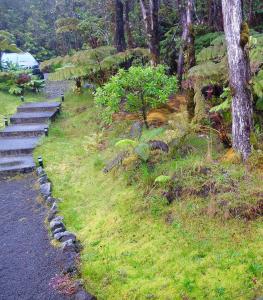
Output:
top-left (95, 66), bottom-right (177, 128)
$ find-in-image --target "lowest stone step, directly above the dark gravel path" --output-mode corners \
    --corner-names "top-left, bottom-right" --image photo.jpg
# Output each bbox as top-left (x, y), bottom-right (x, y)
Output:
top-left (0, 155), bottom-right (36, 176)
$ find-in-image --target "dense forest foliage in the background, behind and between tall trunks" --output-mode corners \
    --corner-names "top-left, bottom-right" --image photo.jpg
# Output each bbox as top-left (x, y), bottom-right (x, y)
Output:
top-left (0, 0), bottom-right (263, 61)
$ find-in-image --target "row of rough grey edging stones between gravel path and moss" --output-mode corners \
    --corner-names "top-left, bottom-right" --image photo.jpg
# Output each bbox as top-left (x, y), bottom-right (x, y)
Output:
top-left (36, 167), bottom-right (97, 300)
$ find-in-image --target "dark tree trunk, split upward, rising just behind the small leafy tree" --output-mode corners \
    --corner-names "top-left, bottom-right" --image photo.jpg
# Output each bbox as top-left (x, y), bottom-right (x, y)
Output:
top-left (140, 0), bottom-right (160, 66)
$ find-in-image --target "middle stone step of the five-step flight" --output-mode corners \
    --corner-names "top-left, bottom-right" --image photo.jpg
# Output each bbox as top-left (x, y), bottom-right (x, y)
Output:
top-left (0, 124), bottom-right (48, 137)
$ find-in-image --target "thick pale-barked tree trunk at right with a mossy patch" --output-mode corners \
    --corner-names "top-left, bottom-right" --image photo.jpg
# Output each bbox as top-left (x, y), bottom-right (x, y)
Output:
top-left (222, 0), bottom-right (252, 160)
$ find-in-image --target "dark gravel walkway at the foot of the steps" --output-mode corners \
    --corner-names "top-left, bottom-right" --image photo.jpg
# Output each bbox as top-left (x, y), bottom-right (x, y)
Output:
top-left (0, 175), bottom-right (65, 300)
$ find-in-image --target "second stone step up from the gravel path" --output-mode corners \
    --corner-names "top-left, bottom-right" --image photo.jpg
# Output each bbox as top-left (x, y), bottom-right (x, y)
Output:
top-left (0, 137), bottom-right (39, 157)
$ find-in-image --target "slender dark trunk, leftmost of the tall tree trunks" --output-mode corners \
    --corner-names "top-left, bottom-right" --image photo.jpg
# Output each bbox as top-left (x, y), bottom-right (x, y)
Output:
top-left (115, 0), bottom-right (126, 52)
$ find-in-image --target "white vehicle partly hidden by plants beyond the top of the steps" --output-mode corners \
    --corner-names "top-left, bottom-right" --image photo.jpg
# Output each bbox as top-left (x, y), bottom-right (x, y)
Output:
top-left (1, 52), bottom-right (38, 69)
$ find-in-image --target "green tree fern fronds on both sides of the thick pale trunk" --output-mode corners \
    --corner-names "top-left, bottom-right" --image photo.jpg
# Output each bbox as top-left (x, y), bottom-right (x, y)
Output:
top-left (188, 31), bottom-right (263, 120)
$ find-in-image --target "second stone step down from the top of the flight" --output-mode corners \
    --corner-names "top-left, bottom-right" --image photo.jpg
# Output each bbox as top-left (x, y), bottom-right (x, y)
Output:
top-left (10, 111), bottom-right (57, 124)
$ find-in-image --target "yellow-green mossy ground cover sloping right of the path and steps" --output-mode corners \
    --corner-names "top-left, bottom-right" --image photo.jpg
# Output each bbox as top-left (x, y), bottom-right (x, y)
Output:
top-left (35, 94), bottom-right (263, 300)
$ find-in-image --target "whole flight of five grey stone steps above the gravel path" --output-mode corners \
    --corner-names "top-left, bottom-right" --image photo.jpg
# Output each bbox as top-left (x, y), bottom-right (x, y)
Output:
top-left (0, 102), bottom-right (61, 176)
